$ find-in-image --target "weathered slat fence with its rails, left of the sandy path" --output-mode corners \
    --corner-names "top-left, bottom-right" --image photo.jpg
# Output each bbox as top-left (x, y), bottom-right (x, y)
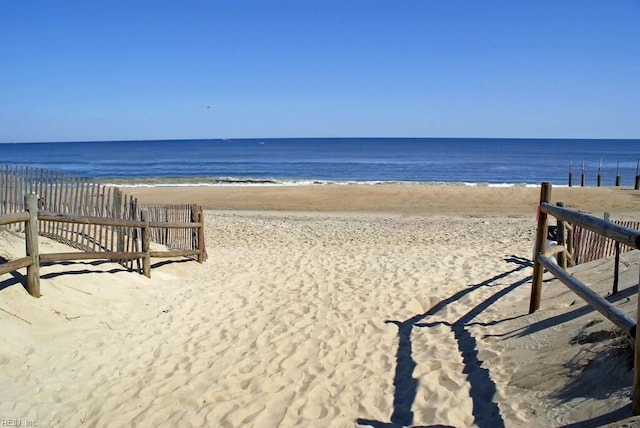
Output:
top-left (0, 165), bottom-right (207, 286)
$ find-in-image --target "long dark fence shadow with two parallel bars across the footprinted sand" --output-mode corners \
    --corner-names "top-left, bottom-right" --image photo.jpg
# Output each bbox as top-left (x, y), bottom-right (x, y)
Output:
top-left (356, 256), bottom-right (531, 428)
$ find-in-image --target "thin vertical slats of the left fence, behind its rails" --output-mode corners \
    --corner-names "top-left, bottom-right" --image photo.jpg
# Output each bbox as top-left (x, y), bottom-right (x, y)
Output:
top-left (0, 165), bottom-right (206, 269)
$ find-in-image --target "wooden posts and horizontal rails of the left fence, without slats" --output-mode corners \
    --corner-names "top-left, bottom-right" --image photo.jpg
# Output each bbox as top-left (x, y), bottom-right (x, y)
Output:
top-left (0, 194), bottom-right (204, 297)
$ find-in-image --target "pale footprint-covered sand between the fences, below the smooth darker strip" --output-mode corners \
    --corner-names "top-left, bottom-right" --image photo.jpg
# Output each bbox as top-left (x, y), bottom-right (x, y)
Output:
top-left (0, 212), bottom-right (636, 427)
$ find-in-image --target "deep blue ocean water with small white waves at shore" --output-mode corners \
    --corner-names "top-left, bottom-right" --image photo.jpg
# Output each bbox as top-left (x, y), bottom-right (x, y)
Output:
top-left (0, 138), bottom-right (640, 186)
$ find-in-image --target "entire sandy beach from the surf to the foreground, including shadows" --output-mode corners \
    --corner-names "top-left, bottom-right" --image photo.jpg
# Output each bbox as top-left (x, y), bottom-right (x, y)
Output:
top-left (0, 185), bottom-right (640, 428)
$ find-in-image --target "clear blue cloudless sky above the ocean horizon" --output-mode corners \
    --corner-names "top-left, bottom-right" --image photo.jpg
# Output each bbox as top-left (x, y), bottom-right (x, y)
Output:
top-left (0, 0), bottom-right (640, 142)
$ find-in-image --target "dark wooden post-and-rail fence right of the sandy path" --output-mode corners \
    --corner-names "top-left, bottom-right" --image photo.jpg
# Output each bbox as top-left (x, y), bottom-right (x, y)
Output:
top-left (529, 183), bottom-right (640, 415)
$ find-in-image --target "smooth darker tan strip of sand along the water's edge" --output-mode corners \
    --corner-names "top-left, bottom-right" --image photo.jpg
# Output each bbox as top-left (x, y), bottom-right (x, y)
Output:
top-left (122, 184), bottom-right (640, 218)
